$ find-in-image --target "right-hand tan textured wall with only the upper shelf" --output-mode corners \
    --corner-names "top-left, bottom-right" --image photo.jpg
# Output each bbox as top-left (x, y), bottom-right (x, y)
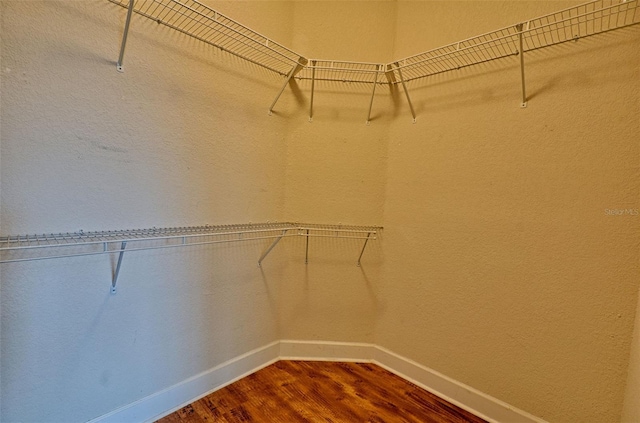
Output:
top-left (376, 2), bottom-right (640, 422)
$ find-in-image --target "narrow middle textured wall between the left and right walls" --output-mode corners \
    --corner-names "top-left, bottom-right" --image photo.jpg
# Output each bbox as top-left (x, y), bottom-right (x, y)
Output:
top-left (278, 1), bottom-right (395, 342)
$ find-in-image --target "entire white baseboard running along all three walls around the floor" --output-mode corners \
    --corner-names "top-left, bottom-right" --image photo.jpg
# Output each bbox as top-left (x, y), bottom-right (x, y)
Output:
top-left (89, 340), bottom-right (546, 423)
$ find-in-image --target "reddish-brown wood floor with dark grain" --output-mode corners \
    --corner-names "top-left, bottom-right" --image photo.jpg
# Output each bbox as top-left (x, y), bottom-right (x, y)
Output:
top-left (158, 361), bottom-right (484, 423)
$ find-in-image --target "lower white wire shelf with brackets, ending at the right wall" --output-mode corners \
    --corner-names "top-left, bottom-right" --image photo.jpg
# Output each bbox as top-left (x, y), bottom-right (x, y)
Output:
top-left (0, 222), bottom-right (382, 293)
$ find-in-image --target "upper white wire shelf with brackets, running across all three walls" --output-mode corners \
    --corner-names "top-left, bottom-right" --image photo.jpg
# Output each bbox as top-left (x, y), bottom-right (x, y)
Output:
top-left (109, 0), bottom-right (640, 123)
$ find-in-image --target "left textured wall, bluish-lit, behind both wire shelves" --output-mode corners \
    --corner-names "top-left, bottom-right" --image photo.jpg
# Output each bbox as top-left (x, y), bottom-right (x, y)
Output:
top-left (0, 1), bottom-right (290, 422)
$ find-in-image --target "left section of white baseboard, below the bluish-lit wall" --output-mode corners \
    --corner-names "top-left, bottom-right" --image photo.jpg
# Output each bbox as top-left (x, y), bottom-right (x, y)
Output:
top-left (89, 341), bottom-right (280, 423)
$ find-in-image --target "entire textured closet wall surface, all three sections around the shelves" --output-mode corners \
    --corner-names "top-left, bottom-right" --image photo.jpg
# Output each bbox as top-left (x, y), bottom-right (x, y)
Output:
top-left (0, 0), bottom-right (640, 422)
